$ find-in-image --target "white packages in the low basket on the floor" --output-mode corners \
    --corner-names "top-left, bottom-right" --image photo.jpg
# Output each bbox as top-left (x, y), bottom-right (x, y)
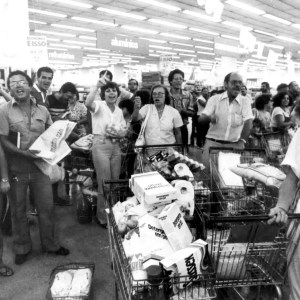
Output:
top-left (50, 268), bottom-right (93, 300)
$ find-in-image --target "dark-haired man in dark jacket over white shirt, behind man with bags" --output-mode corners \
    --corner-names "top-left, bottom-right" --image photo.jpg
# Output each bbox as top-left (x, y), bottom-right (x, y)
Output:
top-left (31, 67), bottom-right (53, 106)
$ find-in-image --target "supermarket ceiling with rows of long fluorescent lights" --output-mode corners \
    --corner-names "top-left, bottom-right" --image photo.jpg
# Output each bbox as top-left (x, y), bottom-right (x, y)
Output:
top-left (29, 0), bottom-right (300, 68)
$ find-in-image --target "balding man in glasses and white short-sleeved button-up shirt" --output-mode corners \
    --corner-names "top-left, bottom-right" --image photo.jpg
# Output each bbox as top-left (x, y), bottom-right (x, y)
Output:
top-left (198, 72), bottom-right (253, 167)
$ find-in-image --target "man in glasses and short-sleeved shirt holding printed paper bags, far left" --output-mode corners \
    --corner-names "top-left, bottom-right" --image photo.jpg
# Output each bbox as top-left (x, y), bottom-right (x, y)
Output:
top-left (0, 71), bottom-right (69, 265)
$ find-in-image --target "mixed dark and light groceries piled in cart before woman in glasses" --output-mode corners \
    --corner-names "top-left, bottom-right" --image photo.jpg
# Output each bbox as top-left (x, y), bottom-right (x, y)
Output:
top-left (147, 147), bottom-right (205, 181)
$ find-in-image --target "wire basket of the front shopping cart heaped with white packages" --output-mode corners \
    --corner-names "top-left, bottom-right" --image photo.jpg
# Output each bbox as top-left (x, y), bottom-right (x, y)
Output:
top-left (104, 180), bottom-right (216, 300)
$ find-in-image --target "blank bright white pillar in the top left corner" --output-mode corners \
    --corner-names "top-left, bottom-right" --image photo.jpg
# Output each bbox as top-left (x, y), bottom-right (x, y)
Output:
top-left (0, 0), bottom-right (29, 69)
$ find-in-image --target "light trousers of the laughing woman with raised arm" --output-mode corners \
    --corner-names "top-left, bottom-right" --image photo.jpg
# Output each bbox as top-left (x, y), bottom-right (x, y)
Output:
top-left (92, 135), bottom-right (121, 223)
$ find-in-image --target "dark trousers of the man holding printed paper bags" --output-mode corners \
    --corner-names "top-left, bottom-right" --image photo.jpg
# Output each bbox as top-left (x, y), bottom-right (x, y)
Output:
top-left (8, 171), bottom-right (59, 254)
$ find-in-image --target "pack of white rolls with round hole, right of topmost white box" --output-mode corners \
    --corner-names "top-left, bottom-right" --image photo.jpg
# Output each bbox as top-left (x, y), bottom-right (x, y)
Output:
top-left (171, 180), bottom-right (195, 216)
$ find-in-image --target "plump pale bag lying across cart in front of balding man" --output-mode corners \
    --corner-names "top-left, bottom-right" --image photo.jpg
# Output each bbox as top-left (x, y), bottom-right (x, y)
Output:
top-left (230, 163), bottom-right (286, 188)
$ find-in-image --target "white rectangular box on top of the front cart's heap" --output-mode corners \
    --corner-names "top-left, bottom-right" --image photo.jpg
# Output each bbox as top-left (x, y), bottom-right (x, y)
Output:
top-left (129, 172), bottom-right (177, 206)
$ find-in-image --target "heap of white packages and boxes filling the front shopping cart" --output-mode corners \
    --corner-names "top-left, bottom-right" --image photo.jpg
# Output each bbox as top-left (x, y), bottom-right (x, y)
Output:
top-left (113, 172), bottom-right (212, 296)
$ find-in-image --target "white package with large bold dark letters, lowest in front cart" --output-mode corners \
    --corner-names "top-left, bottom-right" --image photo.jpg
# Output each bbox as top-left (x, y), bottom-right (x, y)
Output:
top-left (161, 239), bottom-right (207, 289)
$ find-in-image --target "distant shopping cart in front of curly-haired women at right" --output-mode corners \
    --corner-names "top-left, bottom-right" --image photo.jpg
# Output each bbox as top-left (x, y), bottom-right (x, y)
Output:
top-left (261, 132), bottom-right (291, 165)
